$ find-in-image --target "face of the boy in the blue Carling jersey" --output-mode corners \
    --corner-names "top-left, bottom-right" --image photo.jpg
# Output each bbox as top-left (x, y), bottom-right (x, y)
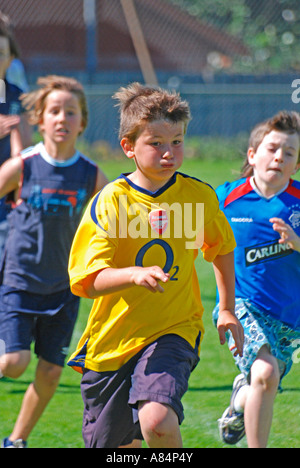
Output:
top-left (248, 130), bottom-right (300, 191)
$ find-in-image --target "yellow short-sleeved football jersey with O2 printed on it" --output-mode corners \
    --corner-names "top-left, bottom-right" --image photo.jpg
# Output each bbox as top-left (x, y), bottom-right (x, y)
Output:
top-left (69, 172), bottom-right (235, 372)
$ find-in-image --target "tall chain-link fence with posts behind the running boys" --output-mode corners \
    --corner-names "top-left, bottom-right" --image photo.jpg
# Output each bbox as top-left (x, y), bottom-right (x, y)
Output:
top-left (0, 0), bottom-right (300, 146)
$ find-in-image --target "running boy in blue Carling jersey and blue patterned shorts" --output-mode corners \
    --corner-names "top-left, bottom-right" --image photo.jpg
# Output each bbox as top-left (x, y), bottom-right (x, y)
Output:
top-left (214, 112), bottom-right (300, 447)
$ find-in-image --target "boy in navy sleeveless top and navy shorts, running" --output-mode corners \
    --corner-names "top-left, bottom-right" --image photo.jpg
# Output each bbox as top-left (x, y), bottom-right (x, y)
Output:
top-left (0, 76), bottom-right (107, 448)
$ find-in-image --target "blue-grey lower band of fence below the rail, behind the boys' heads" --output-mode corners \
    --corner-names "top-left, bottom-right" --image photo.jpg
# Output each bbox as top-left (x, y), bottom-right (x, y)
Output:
top-left (84, 76), bottom-right (300, 147)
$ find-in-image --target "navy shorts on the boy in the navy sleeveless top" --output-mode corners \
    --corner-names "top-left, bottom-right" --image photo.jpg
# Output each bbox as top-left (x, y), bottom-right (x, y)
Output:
top-left (0, 286), bottom-right (79, 367)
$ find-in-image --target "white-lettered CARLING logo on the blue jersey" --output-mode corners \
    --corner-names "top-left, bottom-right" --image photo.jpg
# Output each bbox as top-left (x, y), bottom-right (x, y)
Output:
top-left (245, 241), bottom-right (294, 266)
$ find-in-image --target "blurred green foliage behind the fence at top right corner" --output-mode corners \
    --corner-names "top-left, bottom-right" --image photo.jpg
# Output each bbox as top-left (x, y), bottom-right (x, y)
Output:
top-left (168, 0), bottom-right (300, 73)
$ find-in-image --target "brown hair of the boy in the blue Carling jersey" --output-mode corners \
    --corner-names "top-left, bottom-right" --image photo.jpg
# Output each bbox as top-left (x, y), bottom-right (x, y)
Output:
top-left (241, 111), bottom-right (300, 177)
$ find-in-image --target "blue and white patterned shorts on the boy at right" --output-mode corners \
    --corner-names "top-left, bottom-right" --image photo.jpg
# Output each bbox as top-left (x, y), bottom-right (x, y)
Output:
top-left (213, 298), bottom-right (300, 379)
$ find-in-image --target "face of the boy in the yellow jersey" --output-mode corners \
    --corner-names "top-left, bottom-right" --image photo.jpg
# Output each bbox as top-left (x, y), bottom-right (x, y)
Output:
top-left (121, 120), bottom-right (184, 191)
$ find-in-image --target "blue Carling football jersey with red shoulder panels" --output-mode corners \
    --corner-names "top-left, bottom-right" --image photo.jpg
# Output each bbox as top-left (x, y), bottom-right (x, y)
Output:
top-left (217, 178), bottom-right (300, 328)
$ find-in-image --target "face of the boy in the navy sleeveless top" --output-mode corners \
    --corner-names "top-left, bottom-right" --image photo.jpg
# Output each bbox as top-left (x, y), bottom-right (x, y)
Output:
top-left (40, 90), bottom-right (83, 154)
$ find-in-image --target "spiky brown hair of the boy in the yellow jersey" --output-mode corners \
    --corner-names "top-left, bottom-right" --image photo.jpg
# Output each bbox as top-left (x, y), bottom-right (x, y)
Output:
top-left (113, 83), bottom-right (191, 143)
